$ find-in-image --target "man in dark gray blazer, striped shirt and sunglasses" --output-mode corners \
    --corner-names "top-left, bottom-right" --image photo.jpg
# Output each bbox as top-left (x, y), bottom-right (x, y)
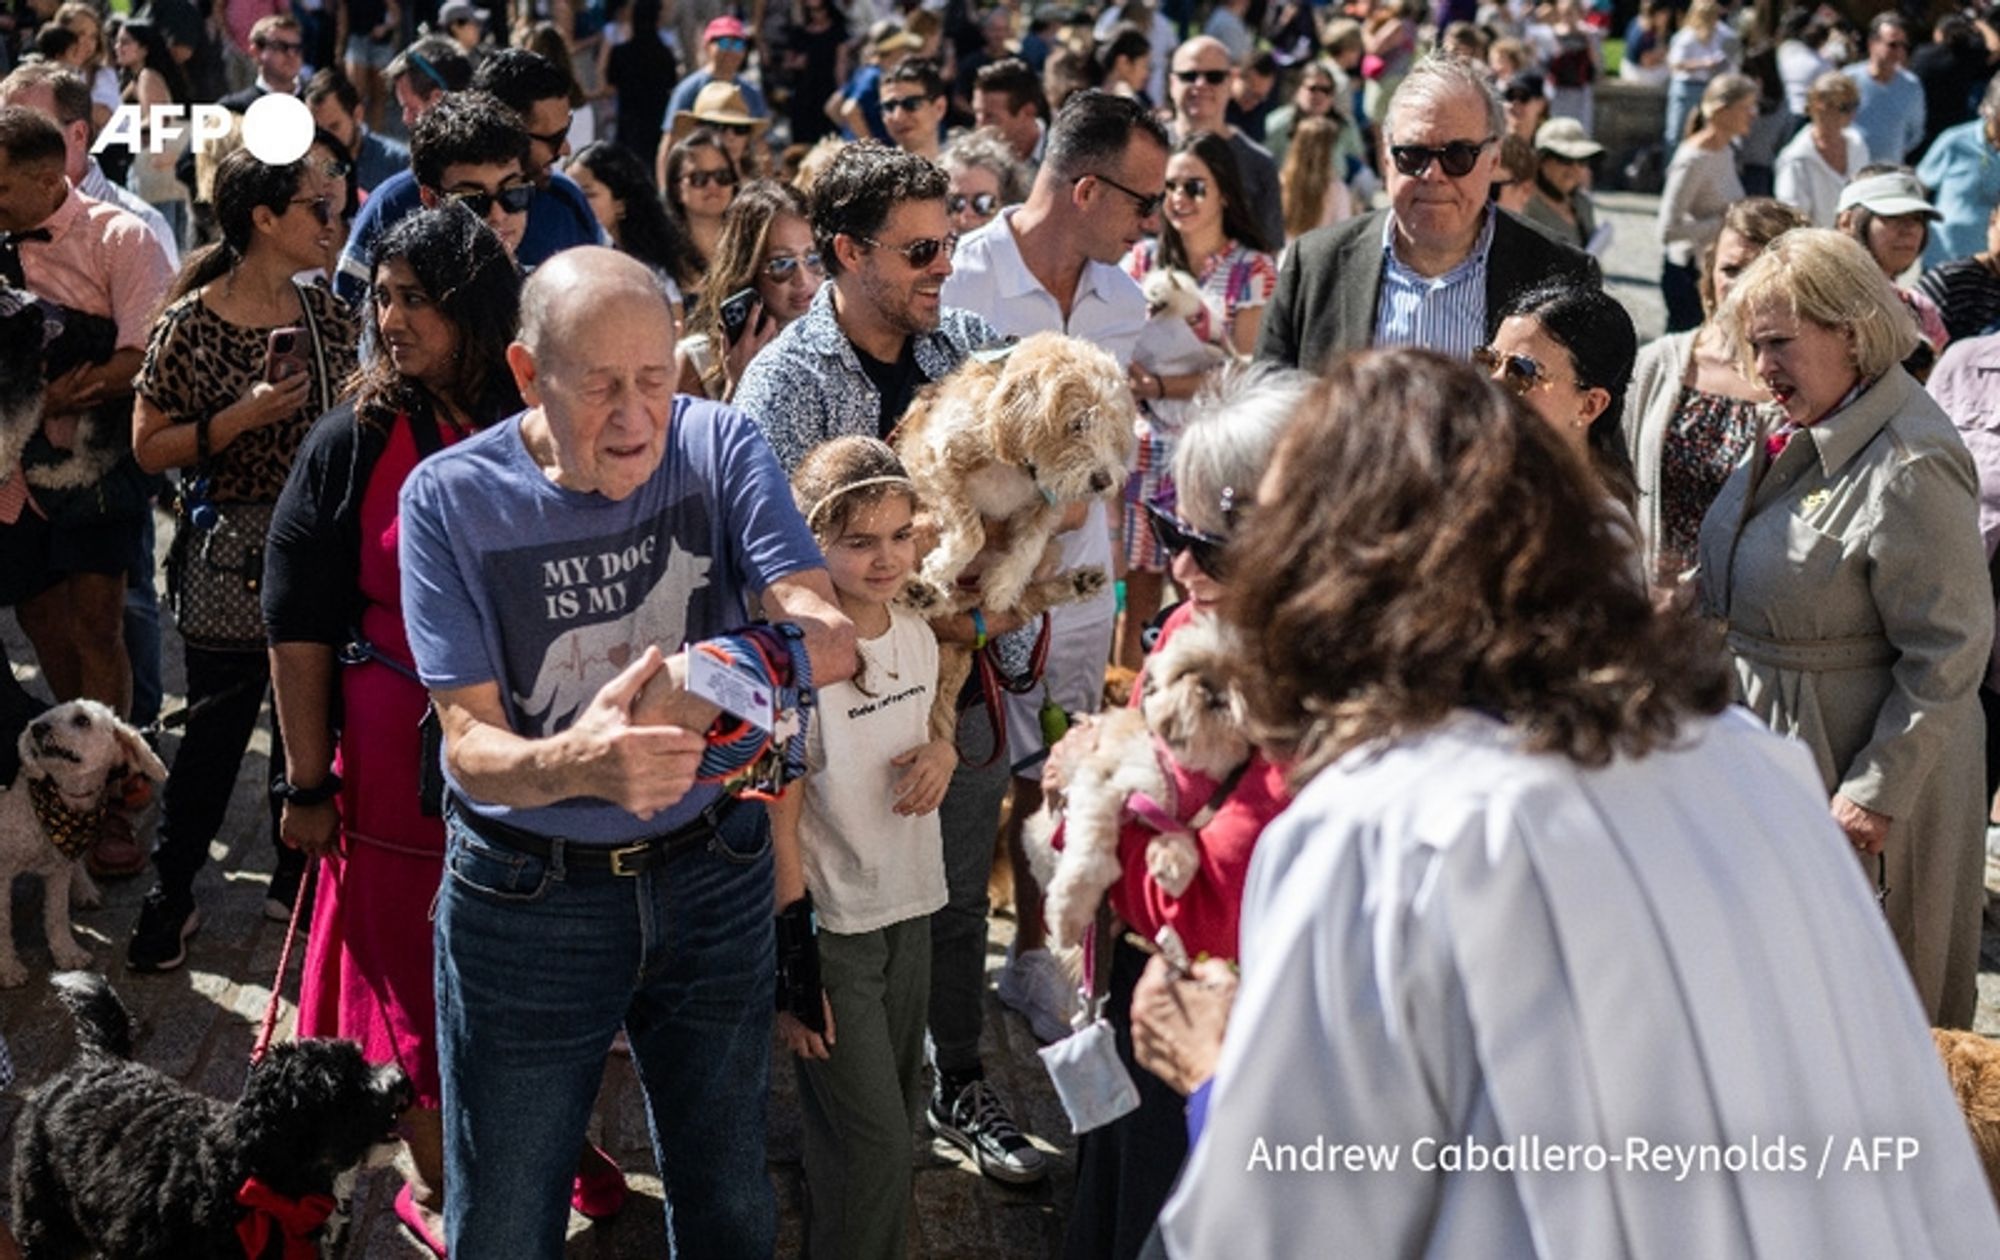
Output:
top-left (1256, 56), bottom-right (1602, 370)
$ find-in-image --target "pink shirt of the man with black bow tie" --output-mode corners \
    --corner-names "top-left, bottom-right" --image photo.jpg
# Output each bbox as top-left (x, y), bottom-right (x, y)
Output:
top-left (20, 188), bottom-right (174, 350)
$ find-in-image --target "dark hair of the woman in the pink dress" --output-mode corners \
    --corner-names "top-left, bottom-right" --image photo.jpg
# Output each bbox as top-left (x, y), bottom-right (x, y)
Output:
top-left (346, 202), bottom-right (520, 426)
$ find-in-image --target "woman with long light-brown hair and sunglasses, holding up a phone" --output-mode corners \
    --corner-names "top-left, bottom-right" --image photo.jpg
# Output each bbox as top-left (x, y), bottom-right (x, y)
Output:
top-left (680, 180), bottom-right (826, 402)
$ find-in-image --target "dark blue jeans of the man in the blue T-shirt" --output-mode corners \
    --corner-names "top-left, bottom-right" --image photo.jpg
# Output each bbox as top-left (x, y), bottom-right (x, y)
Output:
top-left (436, 804), bottom-right (778, 1260)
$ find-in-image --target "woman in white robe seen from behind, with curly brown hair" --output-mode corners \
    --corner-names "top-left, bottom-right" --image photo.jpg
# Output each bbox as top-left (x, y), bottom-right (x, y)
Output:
top-left (1132, 352), bottom-right (2000, 1260)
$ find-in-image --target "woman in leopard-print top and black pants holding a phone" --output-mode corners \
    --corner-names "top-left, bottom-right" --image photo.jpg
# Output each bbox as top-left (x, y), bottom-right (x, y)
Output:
top-left (126, 150), bottom-right (354, 972)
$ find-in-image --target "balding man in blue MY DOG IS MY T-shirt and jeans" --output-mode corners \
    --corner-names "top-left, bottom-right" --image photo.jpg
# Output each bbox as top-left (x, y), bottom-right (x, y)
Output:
top-left (400, 246), bottom-right (854, 1258)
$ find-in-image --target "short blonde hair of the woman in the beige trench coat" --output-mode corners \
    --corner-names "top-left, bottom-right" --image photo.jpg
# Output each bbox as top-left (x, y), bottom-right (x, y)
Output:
top-left (1716, 228), bottom-right (1922, 380)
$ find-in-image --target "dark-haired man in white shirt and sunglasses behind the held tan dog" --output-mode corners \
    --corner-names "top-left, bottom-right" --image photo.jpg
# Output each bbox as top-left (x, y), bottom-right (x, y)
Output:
top-left (932, 90), bottom-right (1168, 1046)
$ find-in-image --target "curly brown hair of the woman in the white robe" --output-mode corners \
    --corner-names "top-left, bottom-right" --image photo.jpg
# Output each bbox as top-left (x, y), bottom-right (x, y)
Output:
top-left (1224, 350), bottom-right (1730, 784)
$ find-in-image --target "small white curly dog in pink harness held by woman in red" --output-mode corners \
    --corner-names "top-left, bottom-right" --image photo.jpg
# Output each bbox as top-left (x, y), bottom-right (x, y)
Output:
top-left (1024, 616), bottom-right (1250, 948)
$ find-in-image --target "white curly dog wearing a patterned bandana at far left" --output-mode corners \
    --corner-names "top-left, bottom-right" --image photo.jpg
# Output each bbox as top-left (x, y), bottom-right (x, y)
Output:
top-left (0, 700), bottom-right (166, 988)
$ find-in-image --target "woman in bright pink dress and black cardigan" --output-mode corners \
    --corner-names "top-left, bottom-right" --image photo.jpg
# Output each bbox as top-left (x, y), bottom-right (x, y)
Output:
top-left (264, 204), bottom-right (540, 1254)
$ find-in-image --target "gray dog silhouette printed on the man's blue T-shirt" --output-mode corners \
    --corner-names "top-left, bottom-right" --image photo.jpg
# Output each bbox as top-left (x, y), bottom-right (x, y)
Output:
top-left (514, 540), bottom-right (710, 732)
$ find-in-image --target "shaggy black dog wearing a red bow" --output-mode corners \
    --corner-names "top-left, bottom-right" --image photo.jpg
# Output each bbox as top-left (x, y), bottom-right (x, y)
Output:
top-left (14, 972), bottom-right (414, 1260)
